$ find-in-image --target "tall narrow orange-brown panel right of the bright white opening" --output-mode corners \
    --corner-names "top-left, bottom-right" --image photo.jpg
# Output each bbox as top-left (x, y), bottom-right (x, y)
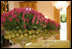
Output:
top-left (67, 4), bottom-right (71, 40)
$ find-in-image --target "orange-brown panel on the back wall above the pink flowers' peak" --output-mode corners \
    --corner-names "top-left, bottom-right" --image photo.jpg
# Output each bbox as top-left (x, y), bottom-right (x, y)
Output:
top-left (19, 1), bottom-right (37, 10)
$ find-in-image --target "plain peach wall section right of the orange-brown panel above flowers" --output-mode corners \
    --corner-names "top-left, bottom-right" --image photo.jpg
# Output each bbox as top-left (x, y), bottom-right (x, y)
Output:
top-left (37, 1), bottom-right (54, 20)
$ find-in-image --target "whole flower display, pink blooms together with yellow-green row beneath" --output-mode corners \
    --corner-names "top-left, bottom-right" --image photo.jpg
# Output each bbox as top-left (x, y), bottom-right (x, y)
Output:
top-left (1, 8), bottom-right (60, 46)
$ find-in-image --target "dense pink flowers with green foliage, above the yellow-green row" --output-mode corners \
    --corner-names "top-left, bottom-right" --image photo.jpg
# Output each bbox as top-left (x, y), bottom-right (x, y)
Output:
top-left (1, 8), bottom-right (60, 30)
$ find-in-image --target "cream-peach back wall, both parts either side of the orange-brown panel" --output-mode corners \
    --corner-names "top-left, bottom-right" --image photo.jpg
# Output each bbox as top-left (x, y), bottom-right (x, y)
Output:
top-left (9, 1), bottom-right (54, 20)
